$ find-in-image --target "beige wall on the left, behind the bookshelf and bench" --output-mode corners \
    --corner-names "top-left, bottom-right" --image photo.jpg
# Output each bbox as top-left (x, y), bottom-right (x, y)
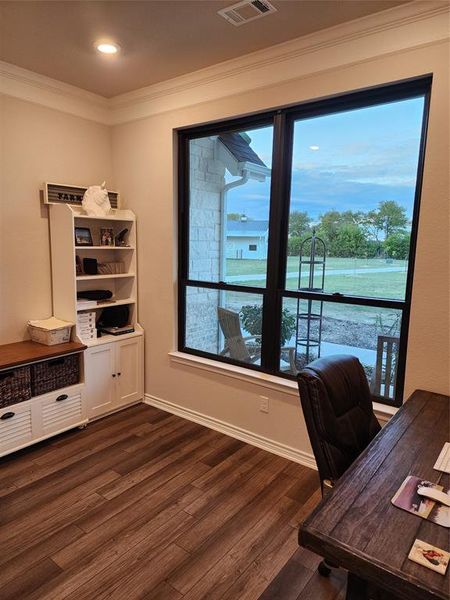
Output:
top-left (0, 95), bottom-right (113, 344)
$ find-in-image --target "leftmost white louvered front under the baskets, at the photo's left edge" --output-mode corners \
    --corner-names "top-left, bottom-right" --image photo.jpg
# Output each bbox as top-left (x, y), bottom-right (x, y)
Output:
top-left (0, 402), bottom-right (33, 456)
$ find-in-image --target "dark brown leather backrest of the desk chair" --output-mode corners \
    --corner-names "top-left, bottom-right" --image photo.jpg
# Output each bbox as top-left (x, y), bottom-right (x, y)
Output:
top-left (297, 355), bottom-right (381, 481)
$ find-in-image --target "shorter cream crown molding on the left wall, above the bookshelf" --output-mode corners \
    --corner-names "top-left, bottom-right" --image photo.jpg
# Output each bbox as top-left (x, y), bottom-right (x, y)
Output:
top-left (0, 61), bottom-right (111, 125)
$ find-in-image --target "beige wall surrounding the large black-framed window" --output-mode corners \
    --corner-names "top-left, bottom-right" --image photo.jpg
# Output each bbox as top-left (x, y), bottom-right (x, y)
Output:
top-left (113, 44), bottom-right (450, 451)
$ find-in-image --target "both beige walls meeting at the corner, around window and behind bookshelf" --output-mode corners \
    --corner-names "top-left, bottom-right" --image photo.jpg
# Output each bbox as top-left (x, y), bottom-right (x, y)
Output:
top-left (0, 31), bottom-right (450, 460)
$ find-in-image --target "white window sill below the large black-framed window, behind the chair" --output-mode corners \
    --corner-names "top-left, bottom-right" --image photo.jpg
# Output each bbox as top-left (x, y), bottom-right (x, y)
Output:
top-left (169, 351), bottom-right (398, 424)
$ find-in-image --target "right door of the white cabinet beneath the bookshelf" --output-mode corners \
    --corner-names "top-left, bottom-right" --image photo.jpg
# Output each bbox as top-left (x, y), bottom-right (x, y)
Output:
top-left (116, 337), bottom-right (143, 406)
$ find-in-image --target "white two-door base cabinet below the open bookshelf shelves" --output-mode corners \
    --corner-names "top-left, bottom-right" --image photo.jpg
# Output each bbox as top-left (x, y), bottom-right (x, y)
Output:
top-left (85, 335), bottom-right (144, 419)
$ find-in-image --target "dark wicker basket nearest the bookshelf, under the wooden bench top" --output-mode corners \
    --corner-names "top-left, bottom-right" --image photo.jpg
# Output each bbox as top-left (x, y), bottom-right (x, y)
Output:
top-left (31, 354), bottom-right (80, 396)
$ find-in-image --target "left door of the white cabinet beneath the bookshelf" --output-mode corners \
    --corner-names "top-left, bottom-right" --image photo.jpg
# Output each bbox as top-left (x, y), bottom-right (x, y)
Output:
top-left (84, 344), bottom-right (117, 419)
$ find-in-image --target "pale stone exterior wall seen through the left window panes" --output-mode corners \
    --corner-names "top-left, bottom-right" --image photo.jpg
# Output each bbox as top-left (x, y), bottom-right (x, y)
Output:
top-left (186, 137), bottom-right (225, 353)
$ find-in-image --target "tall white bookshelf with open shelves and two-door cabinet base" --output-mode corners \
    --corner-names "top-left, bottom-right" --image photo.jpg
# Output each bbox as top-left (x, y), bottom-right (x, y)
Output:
top-left (49, 202), bottom-right (144, 419)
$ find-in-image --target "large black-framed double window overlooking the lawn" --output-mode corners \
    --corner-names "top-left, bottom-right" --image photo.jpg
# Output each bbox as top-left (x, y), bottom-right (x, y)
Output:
top-left (179, 77), bottom-right (431, 405)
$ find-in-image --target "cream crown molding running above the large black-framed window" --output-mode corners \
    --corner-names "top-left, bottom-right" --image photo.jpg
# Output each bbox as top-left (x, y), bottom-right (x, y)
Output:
top-left (110, 0), bottom-right (450, 124)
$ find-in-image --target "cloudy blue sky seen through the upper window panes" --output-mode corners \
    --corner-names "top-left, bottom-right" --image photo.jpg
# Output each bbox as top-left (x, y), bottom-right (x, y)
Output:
top-left (228, 98), bottom-right (424, 221)
